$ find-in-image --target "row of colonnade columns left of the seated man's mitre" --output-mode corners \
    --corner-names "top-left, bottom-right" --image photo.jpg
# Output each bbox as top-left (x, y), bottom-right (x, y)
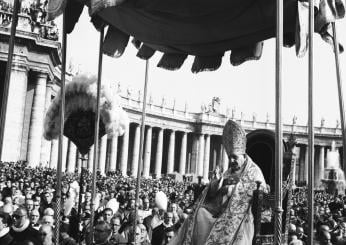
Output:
top-left (45, 123), bottom-right (228, 181)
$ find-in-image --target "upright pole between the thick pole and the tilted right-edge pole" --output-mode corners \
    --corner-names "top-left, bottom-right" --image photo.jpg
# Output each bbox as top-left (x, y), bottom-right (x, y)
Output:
top-left (308, 0), bottom-right (315, 245)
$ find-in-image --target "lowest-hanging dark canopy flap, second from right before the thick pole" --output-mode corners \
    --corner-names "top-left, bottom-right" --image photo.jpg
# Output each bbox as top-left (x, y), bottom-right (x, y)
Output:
top-left (191, 54), bottom-right (223, 73)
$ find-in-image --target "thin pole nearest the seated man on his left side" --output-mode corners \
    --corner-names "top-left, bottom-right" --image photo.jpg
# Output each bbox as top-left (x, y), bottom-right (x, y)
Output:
top-left (133, 60), bottom-right (149, 244)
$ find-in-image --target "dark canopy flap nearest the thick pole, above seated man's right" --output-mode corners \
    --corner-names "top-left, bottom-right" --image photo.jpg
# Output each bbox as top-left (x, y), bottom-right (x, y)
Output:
top-left (230, 42), bottom-right (263, 66)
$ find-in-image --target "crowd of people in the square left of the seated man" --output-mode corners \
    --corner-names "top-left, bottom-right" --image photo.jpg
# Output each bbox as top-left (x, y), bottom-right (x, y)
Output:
top-left (0, 163), bottom-right (203, 245)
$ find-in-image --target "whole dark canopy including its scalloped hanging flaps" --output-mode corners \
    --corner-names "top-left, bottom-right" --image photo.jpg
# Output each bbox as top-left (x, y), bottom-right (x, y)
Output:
top-left (48, 0), bottom-right (345, 72)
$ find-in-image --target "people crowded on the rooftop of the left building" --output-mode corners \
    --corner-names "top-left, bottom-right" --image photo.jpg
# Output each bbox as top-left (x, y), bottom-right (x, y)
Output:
top-left (0, 0), bottom-right (59, 41)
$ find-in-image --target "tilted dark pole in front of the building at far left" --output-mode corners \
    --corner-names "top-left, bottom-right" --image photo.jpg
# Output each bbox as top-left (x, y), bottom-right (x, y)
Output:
top-left (0, 0), bottom-right (21, 160)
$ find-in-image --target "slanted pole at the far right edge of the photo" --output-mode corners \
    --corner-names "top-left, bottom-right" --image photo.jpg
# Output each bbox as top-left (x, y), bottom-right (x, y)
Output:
top-left (332, 22), bottom-right (346, 176)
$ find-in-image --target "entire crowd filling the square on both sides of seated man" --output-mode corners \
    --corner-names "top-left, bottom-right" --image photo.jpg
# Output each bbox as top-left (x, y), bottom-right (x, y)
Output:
top-left (0, 163), bottom-right (346, 245)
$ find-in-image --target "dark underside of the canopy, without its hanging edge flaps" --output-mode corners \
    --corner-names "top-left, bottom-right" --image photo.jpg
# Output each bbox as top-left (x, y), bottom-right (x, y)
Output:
top-left (98, 0), bottom-right (297, 56)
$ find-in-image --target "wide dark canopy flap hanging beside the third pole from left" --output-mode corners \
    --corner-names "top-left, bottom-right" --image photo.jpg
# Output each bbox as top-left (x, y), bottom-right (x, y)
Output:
top-left (103, 26), bottom-right (129, 58)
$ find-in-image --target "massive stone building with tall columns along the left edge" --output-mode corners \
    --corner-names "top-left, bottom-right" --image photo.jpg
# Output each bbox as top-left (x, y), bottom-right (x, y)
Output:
top-left (0, 5), bottom-right (60, 165)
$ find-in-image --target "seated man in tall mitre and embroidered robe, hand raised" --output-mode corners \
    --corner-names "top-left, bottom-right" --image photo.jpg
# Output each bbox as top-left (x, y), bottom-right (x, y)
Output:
top-left (169, 120), bottom-right (266, 245)
